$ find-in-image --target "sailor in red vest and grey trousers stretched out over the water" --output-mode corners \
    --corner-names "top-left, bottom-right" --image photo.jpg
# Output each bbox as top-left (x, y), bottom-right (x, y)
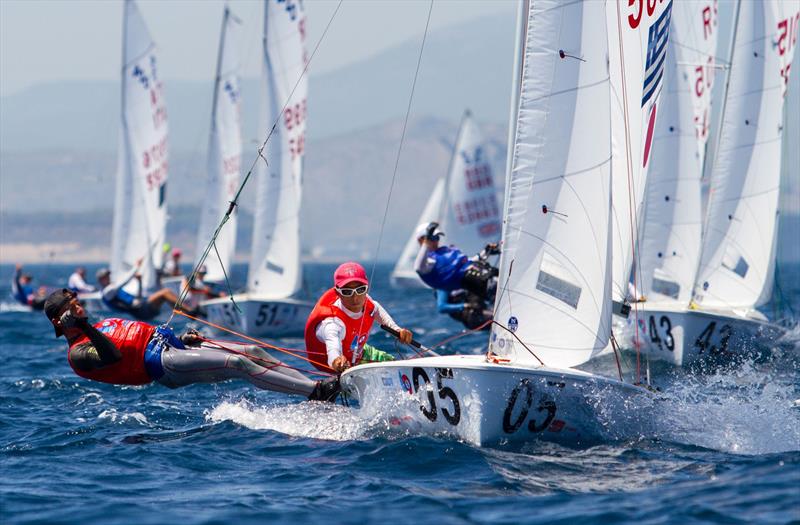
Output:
top-left (44, 288), bottom-right (339, 401)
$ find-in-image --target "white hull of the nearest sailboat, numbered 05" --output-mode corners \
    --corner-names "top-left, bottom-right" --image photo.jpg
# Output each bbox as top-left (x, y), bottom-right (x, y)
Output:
top-left (342, 356), bottom-right (652, 446)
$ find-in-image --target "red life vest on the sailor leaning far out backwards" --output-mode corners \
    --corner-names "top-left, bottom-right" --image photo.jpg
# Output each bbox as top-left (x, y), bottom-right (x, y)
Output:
top-left (67, 318), bottom-right (156, 385)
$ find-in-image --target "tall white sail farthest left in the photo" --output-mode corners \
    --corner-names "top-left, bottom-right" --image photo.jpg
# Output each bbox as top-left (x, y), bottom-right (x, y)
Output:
top-left (111, 0), bottom-right (169, 290)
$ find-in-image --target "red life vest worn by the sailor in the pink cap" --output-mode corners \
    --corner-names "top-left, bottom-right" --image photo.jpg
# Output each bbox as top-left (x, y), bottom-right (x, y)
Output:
top-left (305, 288), bottom-right (375, 372)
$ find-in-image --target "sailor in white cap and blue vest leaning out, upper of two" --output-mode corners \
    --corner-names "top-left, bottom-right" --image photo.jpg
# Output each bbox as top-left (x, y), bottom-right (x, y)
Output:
top-left (414, 222), bottom-right (500, 302)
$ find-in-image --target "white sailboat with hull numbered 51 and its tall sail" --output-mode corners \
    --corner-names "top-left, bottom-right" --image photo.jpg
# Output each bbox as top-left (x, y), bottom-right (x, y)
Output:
top-left (201, 0), bottom-right (314, 337)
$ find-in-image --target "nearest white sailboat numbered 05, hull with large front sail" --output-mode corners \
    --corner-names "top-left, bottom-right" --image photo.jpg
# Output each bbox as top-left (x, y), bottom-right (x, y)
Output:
top-left (342, 0), bottom-right (671, 445)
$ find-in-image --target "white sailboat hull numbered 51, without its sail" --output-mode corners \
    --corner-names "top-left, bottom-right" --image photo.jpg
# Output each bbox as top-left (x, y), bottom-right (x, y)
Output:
top-left (200, 294), bottom-right (314, 337)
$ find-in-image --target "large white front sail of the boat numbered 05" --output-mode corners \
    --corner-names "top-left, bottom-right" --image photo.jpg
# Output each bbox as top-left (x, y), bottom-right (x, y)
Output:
top-left (490, 0), bottom-right (611, 367)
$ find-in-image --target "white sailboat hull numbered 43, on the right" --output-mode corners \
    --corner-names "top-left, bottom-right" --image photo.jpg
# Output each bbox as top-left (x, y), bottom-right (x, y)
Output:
top-left (625, 303), bottom-right (785, 366)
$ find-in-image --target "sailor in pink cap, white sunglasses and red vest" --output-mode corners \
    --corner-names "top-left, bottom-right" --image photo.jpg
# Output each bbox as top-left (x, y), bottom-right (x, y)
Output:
top-left (304, 262), bottom-right (412, 373)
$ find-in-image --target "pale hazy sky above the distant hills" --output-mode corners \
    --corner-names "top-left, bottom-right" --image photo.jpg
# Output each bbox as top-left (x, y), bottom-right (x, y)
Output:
top-left (0, 0), bottom-right (515, 96)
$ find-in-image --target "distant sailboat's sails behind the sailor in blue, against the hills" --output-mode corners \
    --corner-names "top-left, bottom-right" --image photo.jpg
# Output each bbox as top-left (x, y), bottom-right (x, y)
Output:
top-left (391, 110), bottom-right (501, 288)
